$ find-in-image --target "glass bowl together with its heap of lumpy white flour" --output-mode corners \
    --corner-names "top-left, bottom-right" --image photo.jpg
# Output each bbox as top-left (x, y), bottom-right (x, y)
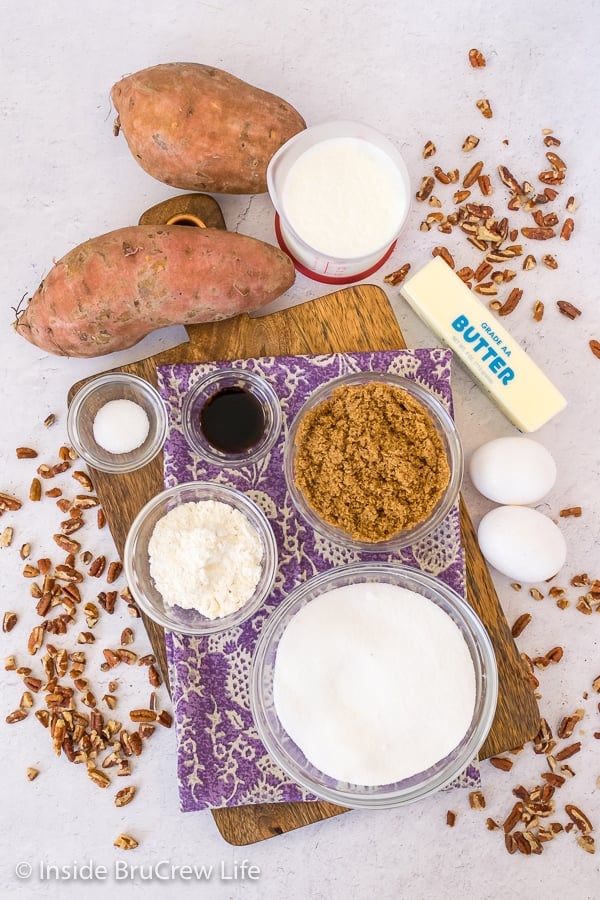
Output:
top-left (123, 482), bottom-right (278, 634)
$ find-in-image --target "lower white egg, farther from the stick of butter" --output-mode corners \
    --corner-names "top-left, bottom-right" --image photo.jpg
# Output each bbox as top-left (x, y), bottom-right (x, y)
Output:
top-left (477, 506), bottom-right (567, 584)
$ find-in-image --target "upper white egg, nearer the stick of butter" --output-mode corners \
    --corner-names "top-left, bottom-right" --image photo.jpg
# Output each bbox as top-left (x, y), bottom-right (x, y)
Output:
top-left (469, 437), bottom-right (556, 506)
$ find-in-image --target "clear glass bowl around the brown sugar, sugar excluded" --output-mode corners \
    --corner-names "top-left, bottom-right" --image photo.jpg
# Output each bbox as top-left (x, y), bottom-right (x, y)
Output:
top-left (283, 372), bottom-right (464, 553)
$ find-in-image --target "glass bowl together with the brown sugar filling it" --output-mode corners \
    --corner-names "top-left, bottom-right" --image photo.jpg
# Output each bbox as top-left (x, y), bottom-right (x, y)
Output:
top-left (284, 372), bottom-right (463, 553)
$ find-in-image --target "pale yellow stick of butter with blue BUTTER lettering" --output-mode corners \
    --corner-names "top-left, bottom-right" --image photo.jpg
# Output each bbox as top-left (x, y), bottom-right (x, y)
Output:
top-left (400, 256), bottom-right (567, 432)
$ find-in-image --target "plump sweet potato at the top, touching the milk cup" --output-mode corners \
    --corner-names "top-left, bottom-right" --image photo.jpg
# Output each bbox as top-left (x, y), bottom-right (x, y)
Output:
top-left (111, 63), bottom-right (306, 194)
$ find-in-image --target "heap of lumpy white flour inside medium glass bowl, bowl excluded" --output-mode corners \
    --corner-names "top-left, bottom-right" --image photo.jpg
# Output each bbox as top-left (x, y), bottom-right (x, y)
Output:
top-left (148, 500), bottom-right (263, 619)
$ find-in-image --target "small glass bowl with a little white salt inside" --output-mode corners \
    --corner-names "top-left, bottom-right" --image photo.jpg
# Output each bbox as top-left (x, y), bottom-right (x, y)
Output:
top-left (67, 372), bottom-right (168, 474)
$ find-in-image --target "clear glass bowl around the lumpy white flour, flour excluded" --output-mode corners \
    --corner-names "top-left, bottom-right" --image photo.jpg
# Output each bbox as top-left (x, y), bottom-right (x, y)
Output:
top-left (123, 481), bottom-right (278, 634)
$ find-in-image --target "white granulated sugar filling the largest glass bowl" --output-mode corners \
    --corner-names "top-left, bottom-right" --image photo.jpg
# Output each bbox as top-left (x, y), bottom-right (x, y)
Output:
top-left (273, 583), bottom-right (475, 785)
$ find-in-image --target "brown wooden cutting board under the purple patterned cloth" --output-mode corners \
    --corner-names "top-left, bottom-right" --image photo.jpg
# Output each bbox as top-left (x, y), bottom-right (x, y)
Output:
top-left (69, 285), bottom-right (540, 846)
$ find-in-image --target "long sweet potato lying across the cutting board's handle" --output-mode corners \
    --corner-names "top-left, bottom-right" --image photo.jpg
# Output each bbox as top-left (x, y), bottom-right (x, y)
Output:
top-left (15, 225), bottom-right (294, 357)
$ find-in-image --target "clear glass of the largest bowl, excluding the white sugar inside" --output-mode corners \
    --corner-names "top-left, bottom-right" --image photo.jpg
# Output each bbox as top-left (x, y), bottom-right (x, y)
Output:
top-left (250, 562), bottom-right (498, 809)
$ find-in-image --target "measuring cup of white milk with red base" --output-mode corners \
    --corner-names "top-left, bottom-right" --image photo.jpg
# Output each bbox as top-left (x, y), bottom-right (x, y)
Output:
top-left (267, 122), bottom-right (410, 284)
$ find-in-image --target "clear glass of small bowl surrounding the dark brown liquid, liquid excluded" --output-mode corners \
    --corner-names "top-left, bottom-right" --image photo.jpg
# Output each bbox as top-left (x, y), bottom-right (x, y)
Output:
top-left (181, 369), bottom-right (282, 466)
